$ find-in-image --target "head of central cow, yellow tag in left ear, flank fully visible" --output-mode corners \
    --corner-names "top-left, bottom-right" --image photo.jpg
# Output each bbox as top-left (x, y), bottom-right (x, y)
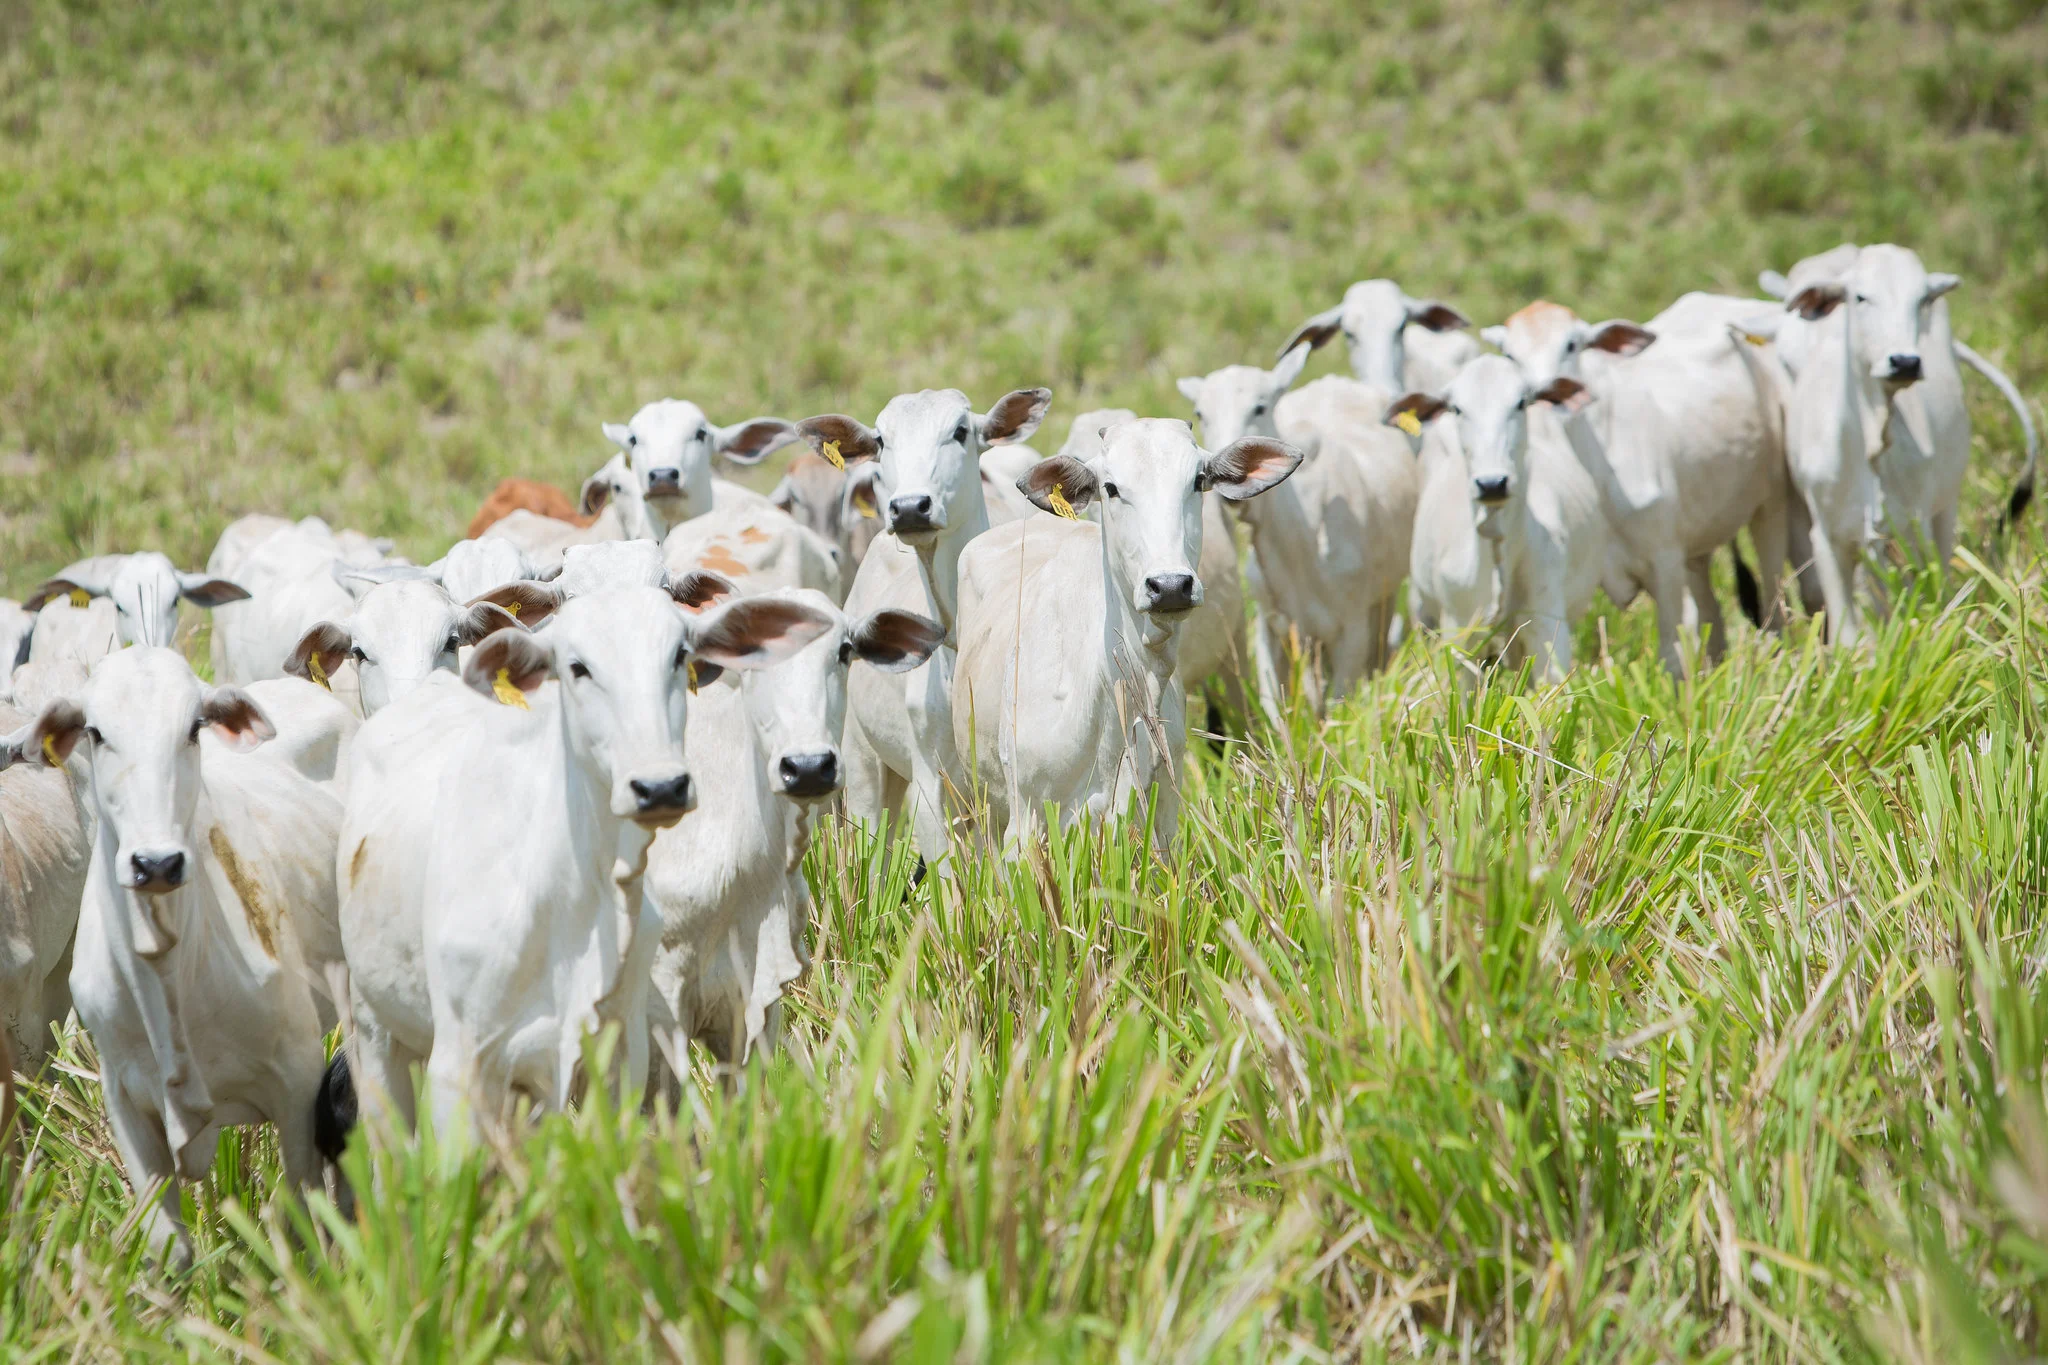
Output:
top-left (1018, 417), bottom-right (1300, 624)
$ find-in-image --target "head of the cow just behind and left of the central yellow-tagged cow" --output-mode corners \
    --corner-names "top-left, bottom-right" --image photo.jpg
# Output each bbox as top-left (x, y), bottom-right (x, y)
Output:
top-left (797, 389), bottom-right (1053, 546)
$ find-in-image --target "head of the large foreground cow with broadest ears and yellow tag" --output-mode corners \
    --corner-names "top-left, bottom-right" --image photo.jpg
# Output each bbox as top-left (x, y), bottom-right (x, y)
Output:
top-left (463, 573), bottom-right (834, 829)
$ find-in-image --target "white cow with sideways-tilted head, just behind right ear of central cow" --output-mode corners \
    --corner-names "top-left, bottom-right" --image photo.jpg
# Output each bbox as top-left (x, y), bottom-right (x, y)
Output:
top-left (1180, 342), bottom-right (1421, 718)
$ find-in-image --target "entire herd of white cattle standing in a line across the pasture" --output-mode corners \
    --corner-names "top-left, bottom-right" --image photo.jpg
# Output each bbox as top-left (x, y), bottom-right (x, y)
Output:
top-left (0, 246), bottom-right (2036, 1261)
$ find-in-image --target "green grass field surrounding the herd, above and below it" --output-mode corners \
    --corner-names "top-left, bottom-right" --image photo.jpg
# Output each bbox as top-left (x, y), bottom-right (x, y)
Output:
top-left (0, 0), bottom-right (2048, 1361)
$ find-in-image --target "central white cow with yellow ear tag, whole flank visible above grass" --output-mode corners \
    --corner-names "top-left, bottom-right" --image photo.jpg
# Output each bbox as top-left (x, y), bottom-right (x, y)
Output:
top-left (952, 417), bottom-right (1303, 853)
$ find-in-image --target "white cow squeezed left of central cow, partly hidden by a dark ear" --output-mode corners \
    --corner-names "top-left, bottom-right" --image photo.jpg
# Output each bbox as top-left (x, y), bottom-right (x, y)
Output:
top-left (799, 389), bottom-right (1053, 860)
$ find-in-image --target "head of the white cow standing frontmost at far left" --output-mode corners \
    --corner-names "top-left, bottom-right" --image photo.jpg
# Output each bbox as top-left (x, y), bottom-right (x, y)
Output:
top-left (10, 645), bottom-right (276, 958)
